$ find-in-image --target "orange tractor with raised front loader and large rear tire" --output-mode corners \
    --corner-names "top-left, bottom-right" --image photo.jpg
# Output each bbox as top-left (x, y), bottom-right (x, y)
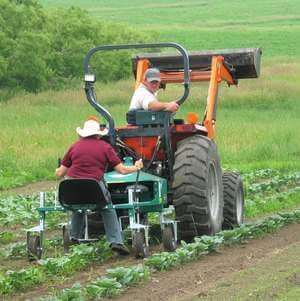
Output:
top-left (84, 43), bottom-right (261, 251)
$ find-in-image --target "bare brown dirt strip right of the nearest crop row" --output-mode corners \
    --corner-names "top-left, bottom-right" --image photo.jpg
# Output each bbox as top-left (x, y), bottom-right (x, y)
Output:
top-left (110, 220), bottom-right (300, 301)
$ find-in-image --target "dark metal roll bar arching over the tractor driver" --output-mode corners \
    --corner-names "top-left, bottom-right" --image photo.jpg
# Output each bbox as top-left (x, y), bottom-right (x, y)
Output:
top-left (83, 42), bottom-right (190, 145)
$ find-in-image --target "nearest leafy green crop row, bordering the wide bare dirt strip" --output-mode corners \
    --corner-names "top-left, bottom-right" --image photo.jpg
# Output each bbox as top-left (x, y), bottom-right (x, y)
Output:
top-left (39, 210), bottom-right (300, 301)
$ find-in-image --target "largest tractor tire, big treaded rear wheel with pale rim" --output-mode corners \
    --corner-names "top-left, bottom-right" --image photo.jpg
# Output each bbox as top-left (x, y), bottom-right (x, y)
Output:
top-left (173, 135), bottom-right (223, 241)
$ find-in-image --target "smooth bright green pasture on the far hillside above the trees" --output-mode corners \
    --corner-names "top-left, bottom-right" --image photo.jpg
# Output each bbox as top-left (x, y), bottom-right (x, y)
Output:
top-left (40, 0), bottom-right (300, 57)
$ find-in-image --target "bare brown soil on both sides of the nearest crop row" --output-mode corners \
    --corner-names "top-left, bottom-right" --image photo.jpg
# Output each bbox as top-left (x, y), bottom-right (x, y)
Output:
top-left (5, 220), bottom-right (300, 301)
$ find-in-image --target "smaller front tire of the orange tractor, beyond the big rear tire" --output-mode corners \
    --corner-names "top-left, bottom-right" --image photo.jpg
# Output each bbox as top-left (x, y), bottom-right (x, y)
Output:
top-left (222, 172), bottom-right (244, 229)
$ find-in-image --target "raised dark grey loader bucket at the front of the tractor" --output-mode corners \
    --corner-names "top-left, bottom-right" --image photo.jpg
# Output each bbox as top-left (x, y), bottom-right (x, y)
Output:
top-left (132, 48), bottom-right (262, 79)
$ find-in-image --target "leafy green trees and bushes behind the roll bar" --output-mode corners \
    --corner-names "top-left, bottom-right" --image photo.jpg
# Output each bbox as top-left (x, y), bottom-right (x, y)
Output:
top-left (0, 0), bottom-right (153, 92)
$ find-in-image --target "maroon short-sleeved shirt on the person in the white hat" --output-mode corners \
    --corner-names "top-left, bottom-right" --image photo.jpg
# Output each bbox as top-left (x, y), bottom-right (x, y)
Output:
top-left (61, 137), bottom-right (121, 180)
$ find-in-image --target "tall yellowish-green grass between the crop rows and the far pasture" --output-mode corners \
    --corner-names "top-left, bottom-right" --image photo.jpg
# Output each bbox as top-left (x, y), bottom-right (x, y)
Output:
top-left (0, 60), bottom-right (300, 189)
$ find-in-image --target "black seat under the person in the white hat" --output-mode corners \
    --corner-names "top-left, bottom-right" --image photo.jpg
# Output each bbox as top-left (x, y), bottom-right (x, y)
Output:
top-left (58, 179), bottom-right (107, 211)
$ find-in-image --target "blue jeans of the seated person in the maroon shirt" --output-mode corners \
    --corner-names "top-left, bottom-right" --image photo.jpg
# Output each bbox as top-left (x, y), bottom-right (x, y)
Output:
top-left (70, 178), bottom-right (123, 244)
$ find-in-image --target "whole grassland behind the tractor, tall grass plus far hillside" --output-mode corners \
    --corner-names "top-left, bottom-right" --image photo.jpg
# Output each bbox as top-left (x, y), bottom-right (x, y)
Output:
top-left (0, 0), bottom-right (300, 189)
